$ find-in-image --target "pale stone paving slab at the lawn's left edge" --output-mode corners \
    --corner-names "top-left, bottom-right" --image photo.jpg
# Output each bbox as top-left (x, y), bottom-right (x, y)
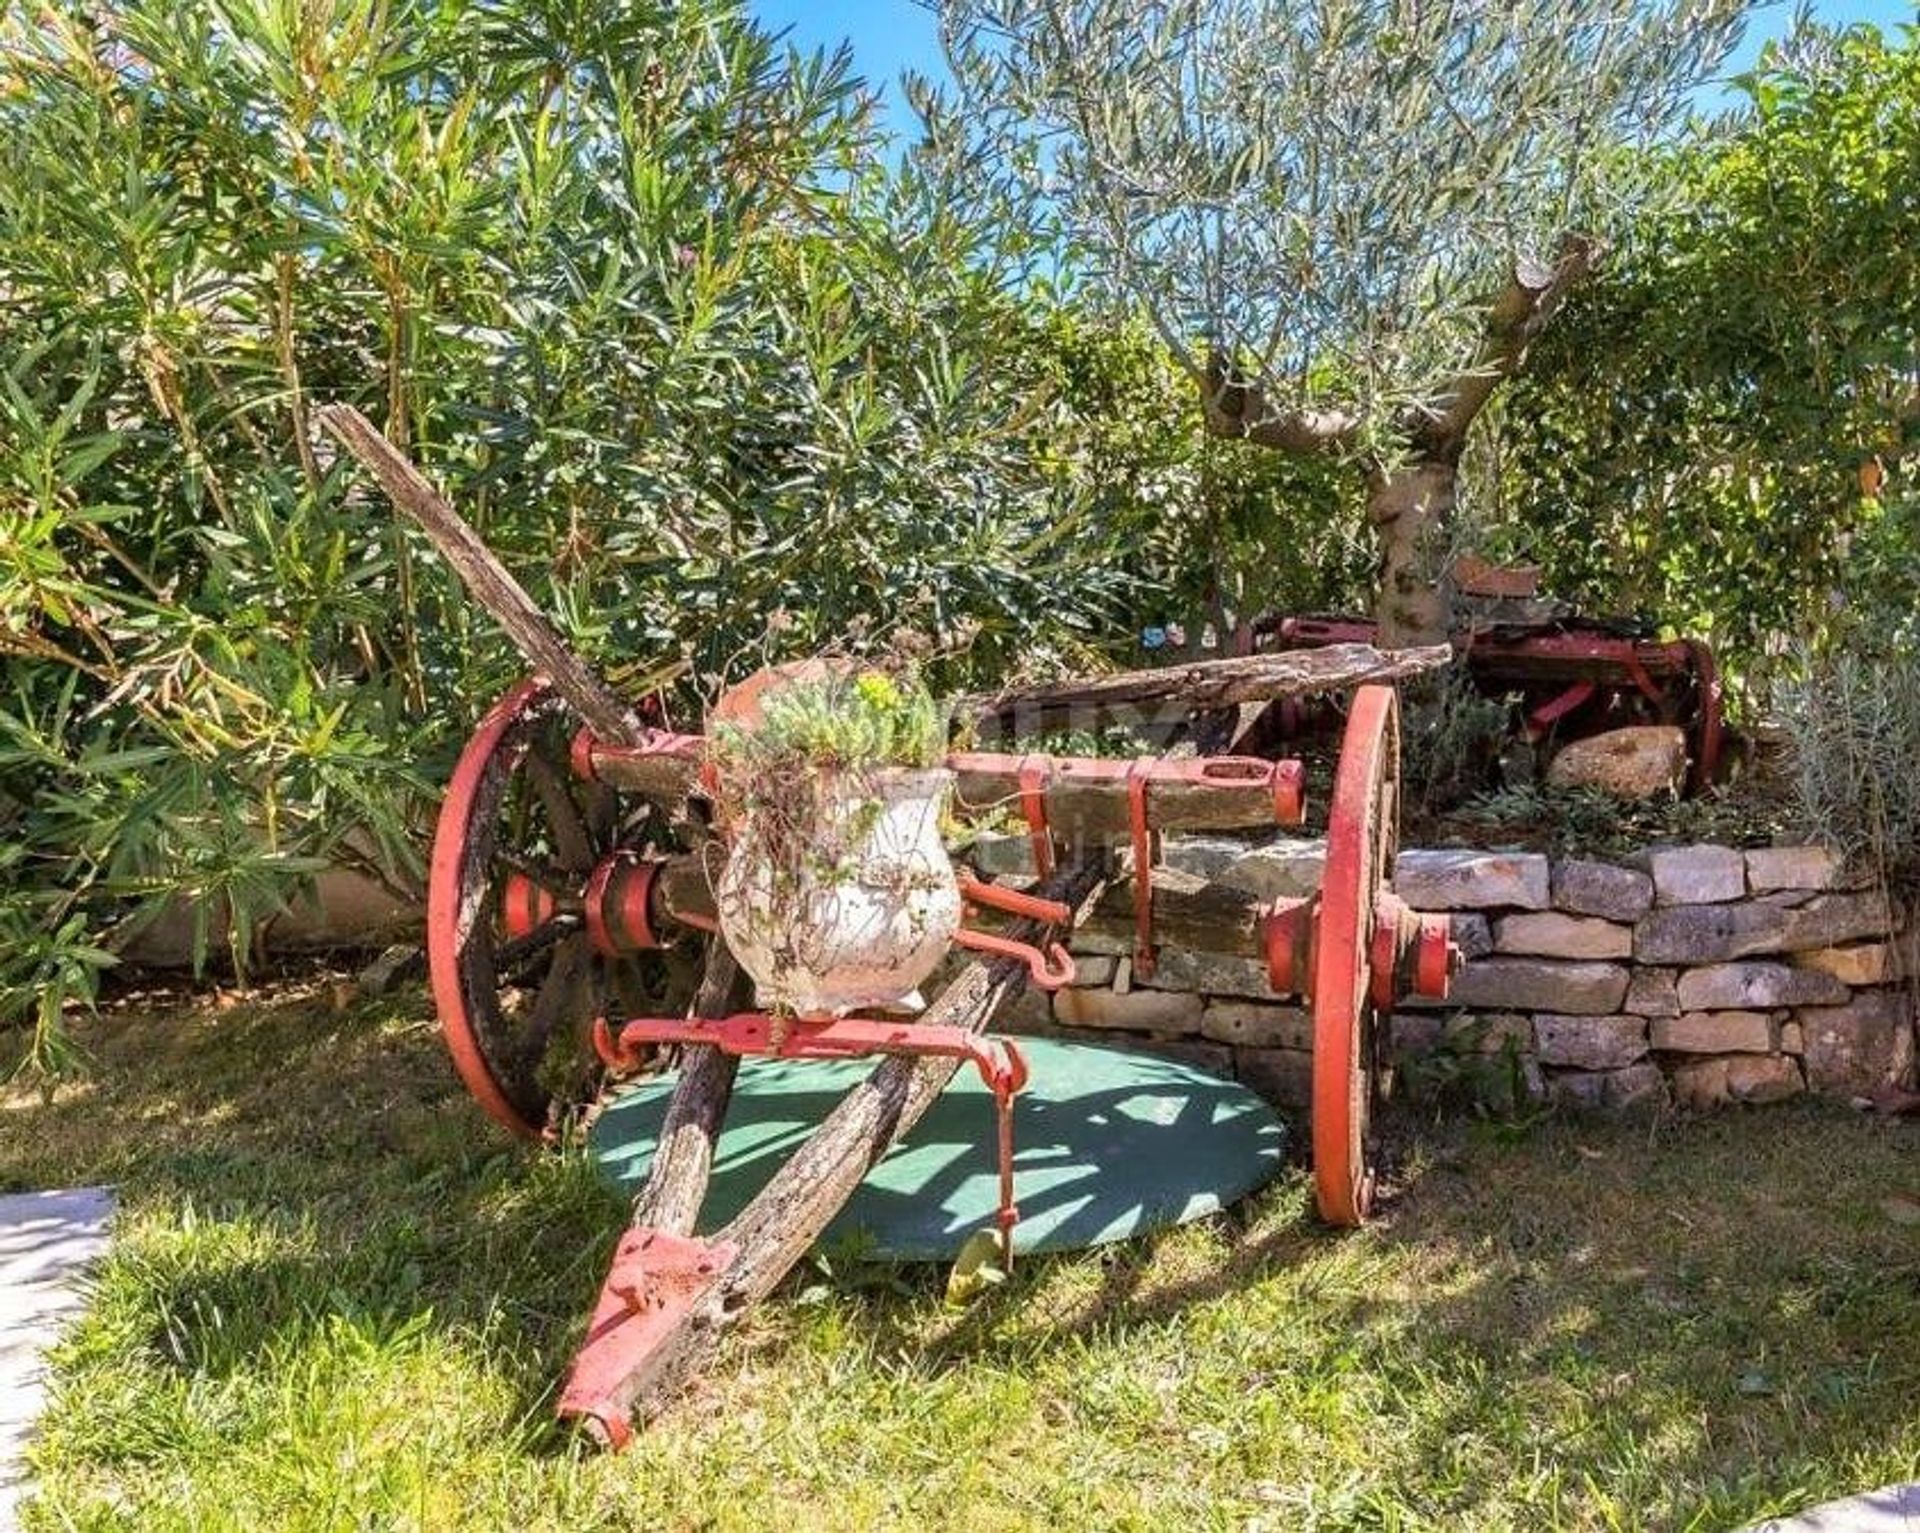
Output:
top-left (0, 1187), bottom-right (113, 1527)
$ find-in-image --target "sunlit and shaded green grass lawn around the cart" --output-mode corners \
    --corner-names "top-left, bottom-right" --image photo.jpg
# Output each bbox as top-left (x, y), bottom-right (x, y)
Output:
top-left (0, 993), bottom-right (1920, 1533)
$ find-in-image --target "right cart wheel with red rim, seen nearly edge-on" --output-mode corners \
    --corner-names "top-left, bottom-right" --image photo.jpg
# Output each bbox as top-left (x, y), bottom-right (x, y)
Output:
top-left (1313, 686), bottom-right (1400, 1226)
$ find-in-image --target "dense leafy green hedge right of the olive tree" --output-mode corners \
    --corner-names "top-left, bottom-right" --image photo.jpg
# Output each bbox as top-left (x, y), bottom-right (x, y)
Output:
top-left (1488, 27), bottom-right (1920, 682)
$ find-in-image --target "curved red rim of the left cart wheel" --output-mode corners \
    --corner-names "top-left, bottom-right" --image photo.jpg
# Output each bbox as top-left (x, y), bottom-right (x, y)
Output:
top-left (426, 676), bottom-right (547, 1139)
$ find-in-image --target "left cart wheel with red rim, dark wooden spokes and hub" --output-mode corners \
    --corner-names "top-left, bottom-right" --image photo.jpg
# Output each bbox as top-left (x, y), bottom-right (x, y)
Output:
top-left (426, 678), bottom-right (687, 1137)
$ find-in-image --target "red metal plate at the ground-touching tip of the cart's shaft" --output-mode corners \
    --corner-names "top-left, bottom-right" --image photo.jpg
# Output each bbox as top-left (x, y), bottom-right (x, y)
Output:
top-left (557, 1228), bottom-right (739, 1450)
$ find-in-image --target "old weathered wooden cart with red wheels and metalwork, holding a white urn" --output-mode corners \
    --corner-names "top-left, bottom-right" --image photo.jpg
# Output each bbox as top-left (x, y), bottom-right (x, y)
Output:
top-left (324, 409), bottom-right (1457, 1445)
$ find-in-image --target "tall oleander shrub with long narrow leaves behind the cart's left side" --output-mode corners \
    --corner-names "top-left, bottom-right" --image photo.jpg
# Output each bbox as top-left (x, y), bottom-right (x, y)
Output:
top-left (0, 0), bottom-right (1228, 1060)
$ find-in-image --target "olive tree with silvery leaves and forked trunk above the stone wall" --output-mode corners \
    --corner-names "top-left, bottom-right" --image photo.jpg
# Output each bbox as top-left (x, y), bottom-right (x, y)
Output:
top-left (918, 0), bottom-right (1743, 644)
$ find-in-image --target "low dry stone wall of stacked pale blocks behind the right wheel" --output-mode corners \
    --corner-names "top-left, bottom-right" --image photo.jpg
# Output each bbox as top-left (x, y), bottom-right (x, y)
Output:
top-left (983, 838), bottom-right (1920, 1108)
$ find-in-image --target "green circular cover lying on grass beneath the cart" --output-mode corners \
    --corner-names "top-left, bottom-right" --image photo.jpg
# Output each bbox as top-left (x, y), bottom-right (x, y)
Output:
top-left (589, 1039), bottom-right (1286, 1262)
